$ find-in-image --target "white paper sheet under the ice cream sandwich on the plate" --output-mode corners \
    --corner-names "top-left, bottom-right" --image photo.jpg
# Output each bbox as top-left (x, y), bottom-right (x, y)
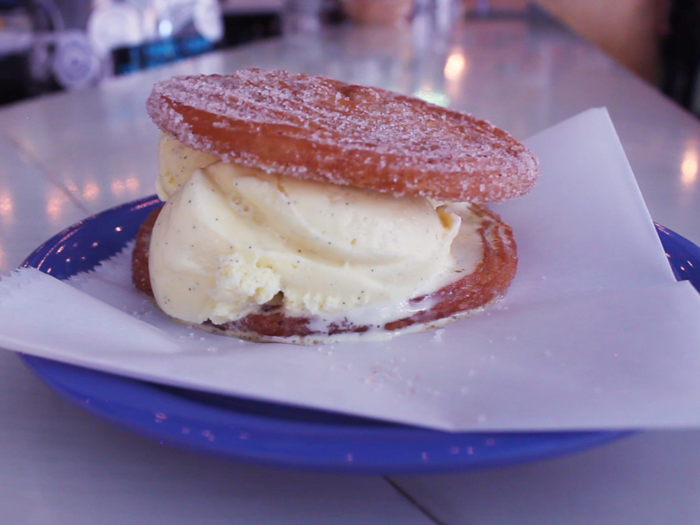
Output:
top-left (0, 110), bottom-right (700, 430)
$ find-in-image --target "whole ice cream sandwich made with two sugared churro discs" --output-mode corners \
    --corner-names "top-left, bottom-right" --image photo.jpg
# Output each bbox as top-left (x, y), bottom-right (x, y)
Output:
top-left (133, 69), bottom-right (538, 344)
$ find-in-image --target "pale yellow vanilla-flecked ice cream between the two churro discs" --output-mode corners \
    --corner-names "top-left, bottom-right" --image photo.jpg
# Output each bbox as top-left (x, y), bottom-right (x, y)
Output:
top-left (150, 136), bottom-right (481, 324)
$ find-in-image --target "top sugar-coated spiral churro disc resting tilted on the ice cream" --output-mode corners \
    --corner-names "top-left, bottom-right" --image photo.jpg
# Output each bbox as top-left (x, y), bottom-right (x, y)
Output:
top-left (147, 69), bottom-right (539, 203)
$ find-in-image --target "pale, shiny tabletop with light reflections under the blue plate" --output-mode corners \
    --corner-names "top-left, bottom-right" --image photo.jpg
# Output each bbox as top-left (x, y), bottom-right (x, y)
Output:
top-left (0, 9), bottom-right (700, 525)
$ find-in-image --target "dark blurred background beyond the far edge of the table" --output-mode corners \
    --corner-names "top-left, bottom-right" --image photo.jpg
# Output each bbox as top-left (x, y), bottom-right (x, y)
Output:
top-left (0, 0), bottom-right (700, 114)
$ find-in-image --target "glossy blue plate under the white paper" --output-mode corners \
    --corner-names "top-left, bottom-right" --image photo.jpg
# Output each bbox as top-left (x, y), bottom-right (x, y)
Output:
top-left (17, 197), bottom-right (700, 474)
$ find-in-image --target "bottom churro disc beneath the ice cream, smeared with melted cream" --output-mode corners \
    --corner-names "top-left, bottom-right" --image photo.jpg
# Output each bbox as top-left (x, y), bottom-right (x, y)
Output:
top-left (132, 205), bottom-right (517, 344)
